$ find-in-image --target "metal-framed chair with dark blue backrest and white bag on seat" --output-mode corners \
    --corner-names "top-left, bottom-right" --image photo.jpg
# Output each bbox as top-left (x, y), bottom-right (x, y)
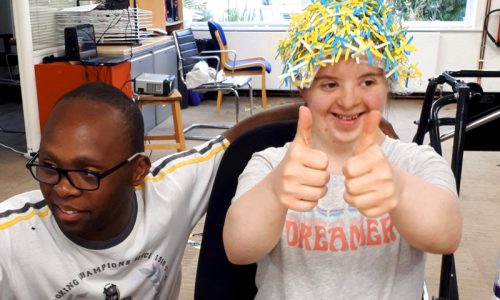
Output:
top-left (173, 28), bottom-right (253, 140)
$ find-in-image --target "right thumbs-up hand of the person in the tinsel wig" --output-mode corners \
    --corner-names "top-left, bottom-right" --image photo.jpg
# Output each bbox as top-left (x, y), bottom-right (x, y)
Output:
top-left (342, 110), bottom-right (399, 217)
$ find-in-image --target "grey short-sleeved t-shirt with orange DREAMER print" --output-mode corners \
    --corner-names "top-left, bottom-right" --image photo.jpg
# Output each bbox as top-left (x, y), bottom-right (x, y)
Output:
top-left (234, 137), bottom-right (456, 300)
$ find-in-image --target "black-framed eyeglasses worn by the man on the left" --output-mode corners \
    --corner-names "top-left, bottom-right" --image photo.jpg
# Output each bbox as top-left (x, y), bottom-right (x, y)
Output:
top-left (26, 152), bottom-right (146, 191)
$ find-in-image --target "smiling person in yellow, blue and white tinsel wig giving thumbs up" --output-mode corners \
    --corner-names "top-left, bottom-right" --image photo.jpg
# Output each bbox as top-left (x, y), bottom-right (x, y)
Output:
top-left (223, 0), bottom-right (462, 300)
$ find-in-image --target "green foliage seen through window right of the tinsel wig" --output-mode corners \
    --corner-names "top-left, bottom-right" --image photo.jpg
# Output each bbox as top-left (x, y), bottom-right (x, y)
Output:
top-left (394, 0), bottom-right (467, 21)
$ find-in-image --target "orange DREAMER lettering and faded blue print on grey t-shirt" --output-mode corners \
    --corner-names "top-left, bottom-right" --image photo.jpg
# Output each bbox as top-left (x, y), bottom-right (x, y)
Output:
top-left (284, 177), bottom-right (398, 252)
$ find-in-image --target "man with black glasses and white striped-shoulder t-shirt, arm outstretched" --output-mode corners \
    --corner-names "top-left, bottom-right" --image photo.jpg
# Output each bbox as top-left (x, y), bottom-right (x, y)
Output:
top-left (0, 83), bottom-right (290, 299)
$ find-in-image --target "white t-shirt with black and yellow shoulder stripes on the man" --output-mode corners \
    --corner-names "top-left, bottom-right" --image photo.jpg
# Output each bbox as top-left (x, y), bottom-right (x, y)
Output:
top-left (0, 137), bottom-right (228, 300)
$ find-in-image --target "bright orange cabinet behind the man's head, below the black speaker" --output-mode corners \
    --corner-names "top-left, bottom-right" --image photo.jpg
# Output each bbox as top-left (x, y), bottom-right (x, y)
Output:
top-left (35, 61), bottom-right (132, 128)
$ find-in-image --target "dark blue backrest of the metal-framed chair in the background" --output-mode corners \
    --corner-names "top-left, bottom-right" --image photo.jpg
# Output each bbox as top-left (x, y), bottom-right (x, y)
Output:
top-left (173, 28), bottom-right (200, 81)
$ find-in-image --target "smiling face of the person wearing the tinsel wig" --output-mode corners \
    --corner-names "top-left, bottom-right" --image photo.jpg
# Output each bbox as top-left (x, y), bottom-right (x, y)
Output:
top-left (301, 59), bottom-right (388, 151)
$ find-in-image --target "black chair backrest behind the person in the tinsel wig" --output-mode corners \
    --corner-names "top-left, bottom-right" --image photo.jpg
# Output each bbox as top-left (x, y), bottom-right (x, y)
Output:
top-left (195, 120), bottom-right (297, 300)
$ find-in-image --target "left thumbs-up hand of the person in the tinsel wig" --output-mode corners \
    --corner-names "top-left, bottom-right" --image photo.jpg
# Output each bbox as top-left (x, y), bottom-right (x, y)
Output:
top-left (272, 106), bottom-right (330, 211)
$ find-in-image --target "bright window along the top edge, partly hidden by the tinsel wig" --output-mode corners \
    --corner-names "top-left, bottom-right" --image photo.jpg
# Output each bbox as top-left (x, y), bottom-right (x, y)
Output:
top-left (187, 0), bottom-right (477, 27)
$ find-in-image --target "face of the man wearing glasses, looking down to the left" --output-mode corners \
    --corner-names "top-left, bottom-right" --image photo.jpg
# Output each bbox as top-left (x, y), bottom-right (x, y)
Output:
top-left (39, 99), bottom-right (145, 240)
